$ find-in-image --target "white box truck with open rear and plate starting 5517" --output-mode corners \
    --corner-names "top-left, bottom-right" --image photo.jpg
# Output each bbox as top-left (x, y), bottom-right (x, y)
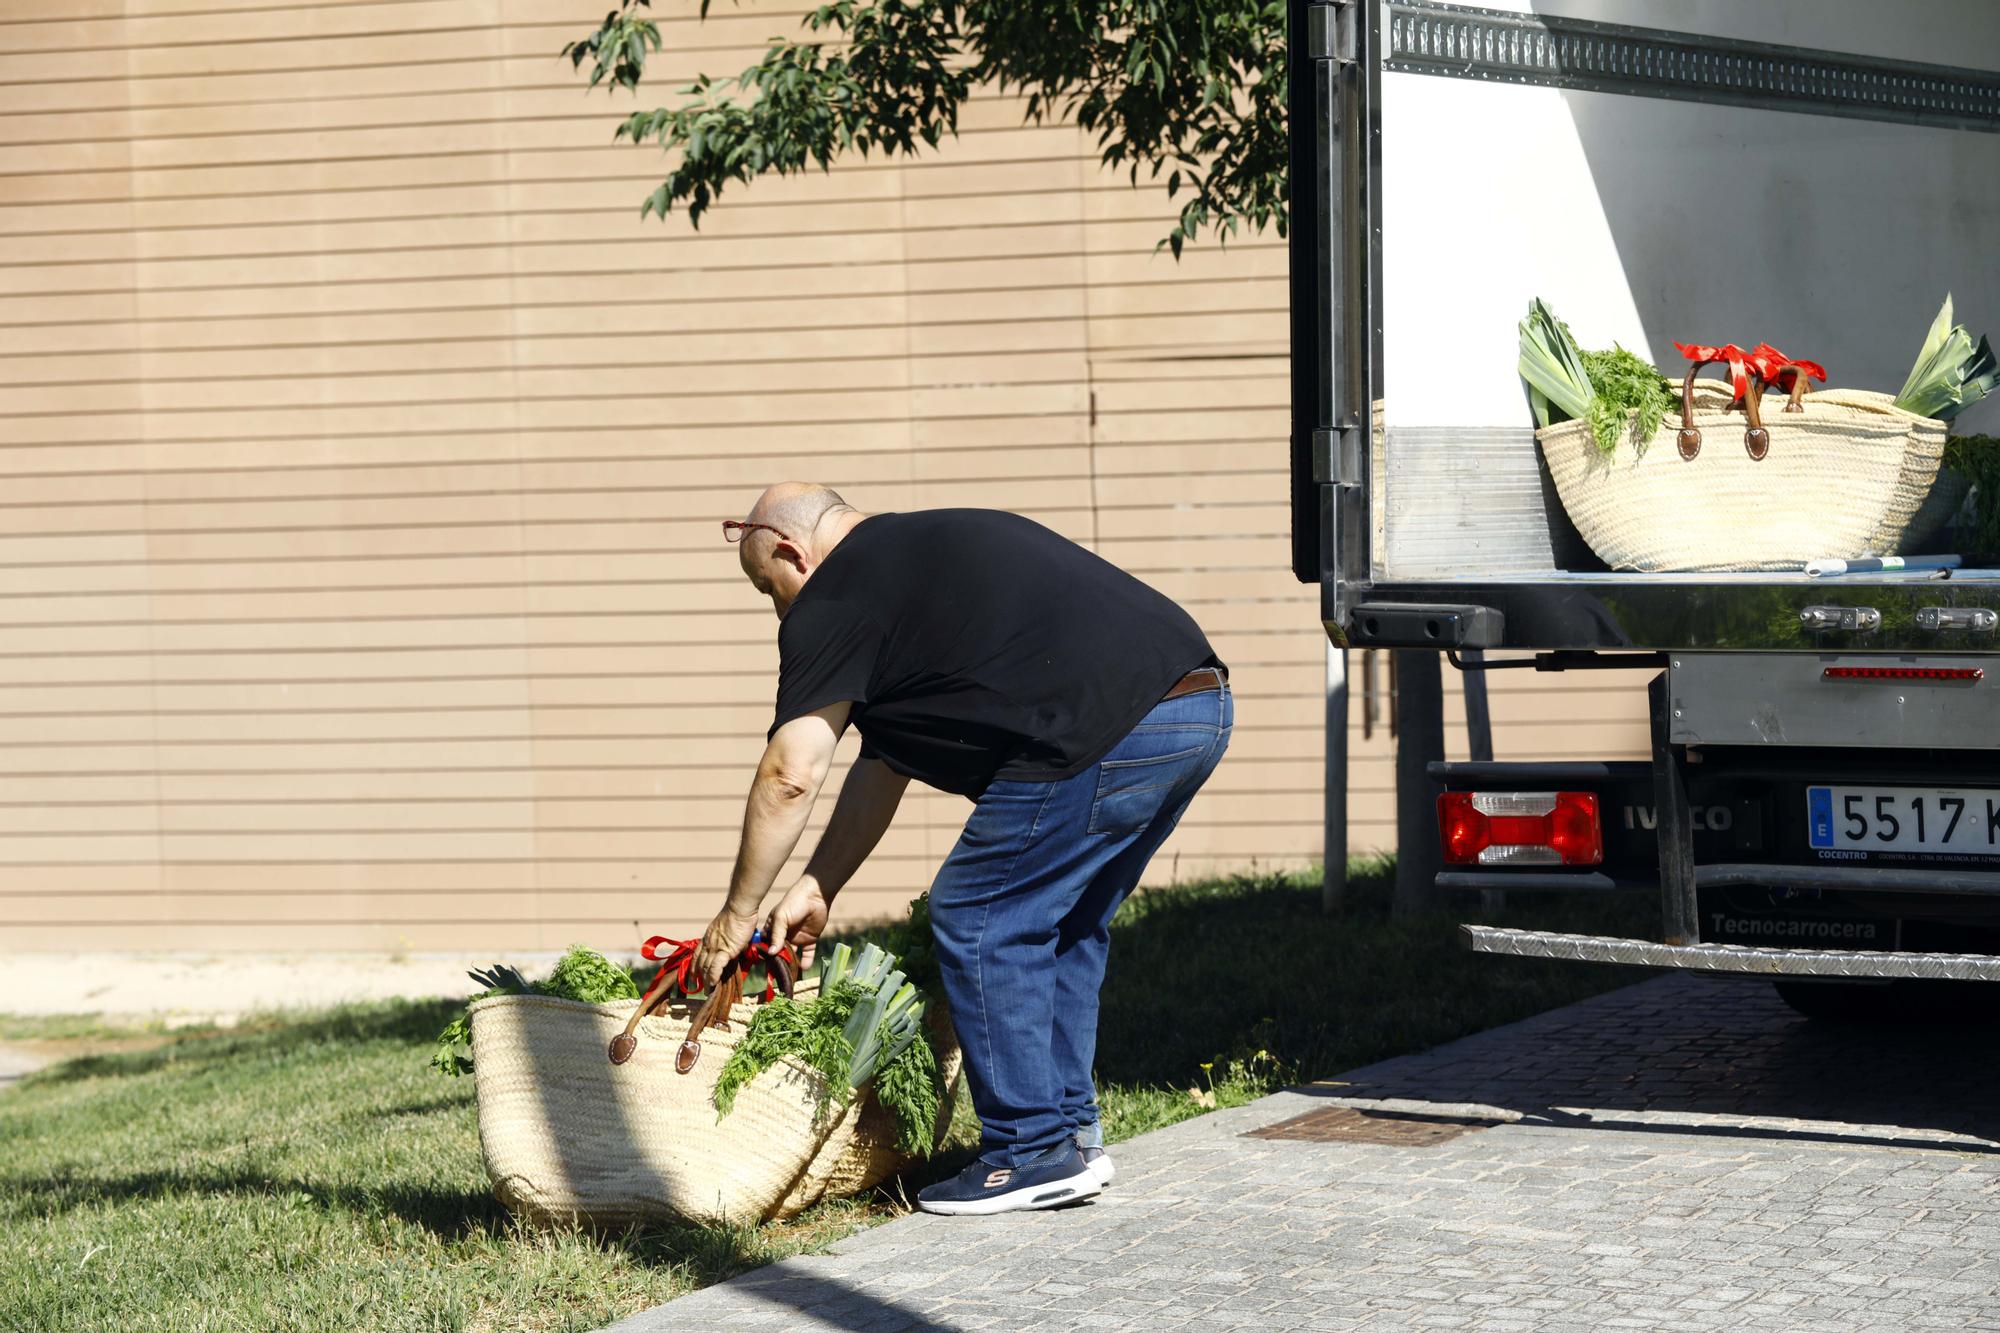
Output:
top-left (1290, 0), bottom-right (2000, 1015)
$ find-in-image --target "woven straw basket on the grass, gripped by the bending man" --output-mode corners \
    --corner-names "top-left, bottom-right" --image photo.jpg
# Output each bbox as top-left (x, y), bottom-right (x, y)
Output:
top-left (470, 981), bottom-right (960, 1223)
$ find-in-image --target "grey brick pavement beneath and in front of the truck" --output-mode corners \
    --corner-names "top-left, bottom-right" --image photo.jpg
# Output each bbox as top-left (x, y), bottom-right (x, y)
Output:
top-left (616, 975), bottom-right (2000, 1333)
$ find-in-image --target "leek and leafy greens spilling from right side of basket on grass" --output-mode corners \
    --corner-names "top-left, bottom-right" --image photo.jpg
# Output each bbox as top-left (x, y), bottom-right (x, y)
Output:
top-left (716, 932), bottom-right (942, 1153)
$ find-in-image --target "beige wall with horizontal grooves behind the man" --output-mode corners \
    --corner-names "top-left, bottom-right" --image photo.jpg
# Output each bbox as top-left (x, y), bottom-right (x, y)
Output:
top-left (0, 0), bottom-right (1640, 949)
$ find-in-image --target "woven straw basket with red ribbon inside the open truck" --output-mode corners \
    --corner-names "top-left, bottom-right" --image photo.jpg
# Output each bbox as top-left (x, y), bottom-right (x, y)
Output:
top-left (1536, 366), bottom-right (1946, 570)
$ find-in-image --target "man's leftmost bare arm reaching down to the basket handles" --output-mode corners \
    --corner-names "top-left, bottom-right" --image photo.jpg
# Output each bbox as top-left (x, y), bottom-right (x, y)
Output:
top-left (696, 703), bottom-right (852, 983)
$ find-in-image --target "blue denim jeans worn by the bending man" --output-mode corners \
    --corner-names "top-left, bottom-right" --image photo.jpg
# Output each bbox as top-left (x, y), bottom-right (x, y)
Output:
top-left (930, 687), bottom-right (1236, 1167)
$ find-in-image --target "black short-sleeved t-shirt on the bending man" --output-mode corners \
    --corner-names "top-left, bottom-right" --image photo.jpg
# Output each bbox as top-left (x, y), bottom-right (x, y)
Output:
top-left (772, 508), bottom-right (1222, 797)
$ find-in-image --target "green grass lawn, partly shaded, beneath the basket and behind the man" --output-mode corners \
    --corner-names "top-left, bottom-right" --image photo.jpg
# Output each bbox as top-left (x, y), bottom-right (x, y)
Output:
top-left (0, 867), bottom-right (1658, 1333)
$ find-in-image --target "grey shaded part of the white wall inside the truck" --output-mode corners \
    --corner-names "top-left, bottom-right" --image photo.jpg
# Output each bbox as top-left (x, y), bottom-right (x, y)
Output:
top-left (1532, 0), bottom-right (2000, 420)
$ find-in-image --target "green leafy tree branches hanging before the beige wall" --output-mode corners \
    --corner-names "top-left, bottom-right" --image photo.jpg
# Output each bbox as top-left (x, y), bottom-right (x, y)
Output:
top-left (566, 0), bottom-right (1288, 256)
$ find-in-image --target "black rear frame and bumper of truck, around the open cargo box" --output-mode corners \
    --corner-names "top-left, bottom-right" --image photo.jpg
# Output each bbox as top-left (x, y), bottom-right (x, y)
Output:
top-left (1290, 0), bottom-right (2000, 989)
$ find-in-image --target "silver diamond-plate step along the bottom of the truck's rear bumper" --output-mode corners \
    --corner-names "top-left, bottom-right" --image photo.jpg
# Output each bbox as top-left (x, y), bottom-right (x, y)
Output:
top-left (1460, 925), bottom-right (2000, 981)
